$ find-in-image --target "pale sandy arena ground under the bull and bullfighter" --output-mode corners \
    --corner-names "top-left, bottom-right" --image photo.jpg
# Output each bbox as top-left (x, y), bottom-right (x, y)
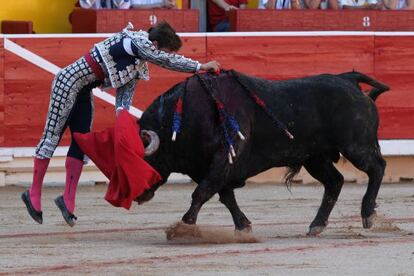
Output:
top-left (0, 183), bottom-right (414, 275)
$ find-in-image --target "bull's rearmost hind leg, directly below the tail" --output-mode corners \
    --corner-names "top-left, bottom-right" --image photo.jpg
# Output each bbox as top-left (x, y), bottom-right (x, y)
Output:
top-left (344, 147), bottom-right (386, 228)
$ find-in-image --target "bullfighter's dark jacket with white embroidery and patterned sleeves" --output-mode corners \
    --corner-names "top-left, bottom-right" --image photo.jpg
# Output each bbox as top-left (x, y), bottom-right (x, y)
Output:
top-left (92, 27), bottom-right (201, 109)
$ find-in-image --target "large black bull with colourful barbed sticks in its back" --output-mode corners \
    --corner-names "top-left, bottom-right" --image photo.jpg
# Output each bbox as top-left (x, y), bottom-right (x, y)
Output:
top-left (136, 71), bottom-right (388, 234)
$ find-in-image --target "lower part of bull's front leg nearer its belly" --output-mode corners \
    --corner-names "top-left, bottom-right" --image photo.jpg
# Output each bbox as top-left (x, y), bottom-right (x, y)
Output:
top-left (219, 188), bottom-right (251, 232)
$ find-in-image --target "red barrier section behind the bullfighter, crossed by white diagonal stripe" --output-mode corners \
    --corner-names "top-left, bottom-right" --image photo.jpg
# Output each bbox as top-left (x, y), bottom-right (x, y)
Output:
top-left (0, 37), bottom-right (206, 146)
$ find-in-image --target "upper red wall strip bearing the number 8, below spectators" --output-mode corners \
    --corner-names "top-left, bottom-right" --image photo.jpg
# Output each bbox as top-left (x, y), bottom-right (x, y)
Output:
top-left (230, 9), bottom-right (414, 32)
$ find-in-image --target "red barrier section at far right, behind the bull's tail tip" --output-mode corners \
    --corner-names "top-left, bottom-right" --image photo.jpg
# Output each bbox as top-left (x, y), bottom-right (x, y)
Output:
top-left (374, 36), bottom-right (414, 138)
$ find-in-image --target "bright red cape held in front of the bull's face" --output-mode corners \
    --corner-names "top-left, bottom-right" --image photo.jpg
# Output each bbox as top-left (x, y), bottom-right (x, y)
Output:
top-left (74, 110), bottom-right (161, 209)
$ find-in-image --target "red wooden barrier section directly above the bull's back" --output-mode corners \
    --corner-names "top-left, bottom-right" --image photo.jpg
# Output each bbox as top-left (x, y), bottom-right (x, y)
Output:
top-left (207, 36), bottom-right (374, 79)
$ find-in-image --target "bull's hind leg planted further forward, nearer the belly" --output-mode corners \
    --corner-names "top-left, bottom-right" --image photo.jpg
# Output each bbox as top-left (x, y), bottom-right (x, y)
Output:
top-left (304, 157), bottom-right (344, 235)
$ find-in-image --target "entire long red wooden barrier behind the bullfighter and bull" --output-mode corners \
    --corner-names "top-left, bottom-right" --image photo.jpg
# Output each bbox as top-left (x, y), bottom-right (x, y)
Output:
top-left (0, 33), bottom-right (414, 147)
